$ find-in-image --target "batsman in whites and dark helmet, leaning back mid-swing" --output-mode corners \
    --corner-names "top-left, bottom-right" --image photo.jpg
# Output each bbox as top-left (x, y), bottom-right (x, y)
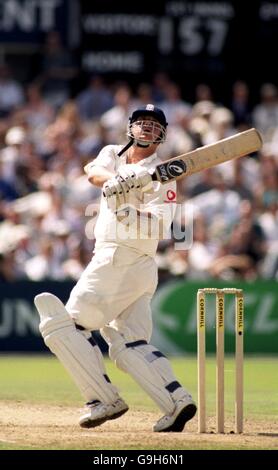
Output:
top-left (35, 104), bottom-right (196, 432)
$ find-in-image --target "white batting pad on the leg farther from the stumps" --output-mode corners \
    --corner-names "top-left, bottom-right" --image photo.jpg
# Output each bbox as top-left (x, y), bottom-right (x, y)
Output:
top-left (34, 292), bottom-right (119, 404)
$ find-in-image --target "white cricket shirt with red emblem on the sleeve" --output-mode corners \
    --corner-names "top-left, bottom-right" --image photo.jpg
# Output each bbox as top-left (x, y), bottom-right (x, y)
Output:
top-left (91, 145), bottom-right (176, 257)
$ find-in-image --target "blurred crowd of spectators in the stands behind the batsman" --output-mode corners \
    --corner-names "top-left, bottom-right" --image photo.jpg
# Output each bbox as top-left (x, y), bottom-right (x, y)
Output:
top-left (0, 34), bottom-right (278, 282)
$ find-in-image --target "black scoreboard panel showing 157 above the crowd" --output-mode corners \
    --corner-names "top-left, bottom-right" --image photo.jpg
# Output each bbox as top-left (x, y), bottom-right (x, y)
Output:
top-left (81, 0), bottom-right (278, 94)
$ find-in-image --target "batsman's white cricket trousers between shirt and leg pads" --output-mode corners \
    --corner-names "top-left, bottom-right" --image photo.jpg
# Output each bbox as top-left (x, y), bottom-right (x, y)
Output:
top-left (66, 246), bottom-right (157, 342)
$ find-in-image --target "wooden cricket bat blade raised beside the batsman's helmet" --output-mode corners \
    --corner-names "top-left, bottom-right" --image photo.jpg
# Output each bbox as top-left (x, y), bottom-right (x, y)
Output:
top-left (152, 128), bottom-right (262, 184)
